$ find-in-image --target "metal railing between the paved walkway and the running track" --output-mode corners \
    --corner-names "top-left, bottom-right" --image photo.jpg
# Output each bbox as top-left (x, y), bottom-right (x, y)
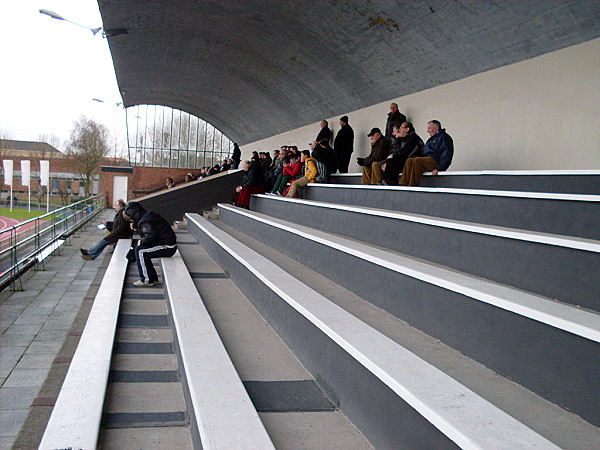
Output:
top-left (0, 195), bottom-right (106, 291)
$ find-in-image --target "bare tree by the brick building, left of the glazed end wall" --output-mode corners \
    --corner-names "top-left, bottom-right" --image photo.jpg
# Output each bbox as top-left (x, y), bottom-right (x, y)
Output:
top-left (67, 116), bottom-right (110, 195)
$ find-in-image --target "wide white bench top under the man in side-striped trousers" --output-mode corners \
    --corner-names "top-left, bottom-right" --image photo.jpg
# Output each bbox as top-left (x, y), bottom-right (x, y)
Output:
top-left (161, 251), bottom-right (275, 450)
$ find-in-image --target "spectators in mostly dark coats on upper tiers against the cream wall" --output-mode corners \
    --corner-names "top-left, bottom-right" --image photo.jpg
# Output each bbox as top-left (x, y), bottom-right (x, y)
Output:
top-left (233, 103), bottom-right (454, 208)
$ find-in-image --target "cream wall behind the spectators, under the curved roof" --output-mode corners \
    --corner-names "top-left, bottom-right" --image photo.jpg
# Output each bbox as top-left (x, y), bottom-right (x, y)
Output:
top-left (242, 39), bottom-right (600, 172)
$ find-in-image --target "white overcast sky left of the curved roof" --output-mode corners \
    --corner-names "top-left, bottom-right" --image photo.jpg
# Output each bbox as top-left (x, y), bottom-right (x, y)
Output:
top-left (0, 0), bottom-right (126, 150)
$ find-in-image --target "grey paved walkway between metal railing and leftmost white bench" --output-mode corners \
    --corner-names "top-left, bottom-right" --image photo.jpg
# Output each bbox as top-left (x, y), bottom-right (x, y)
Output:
top-left (0, 210), bottom-right (113, 450)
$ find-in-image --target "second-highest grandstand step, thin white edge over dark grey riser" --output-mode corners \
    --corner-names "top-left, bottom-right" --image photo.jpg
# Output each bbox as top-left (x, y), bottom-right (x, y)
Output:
top-left (304, 184), bottom-right (600, 240)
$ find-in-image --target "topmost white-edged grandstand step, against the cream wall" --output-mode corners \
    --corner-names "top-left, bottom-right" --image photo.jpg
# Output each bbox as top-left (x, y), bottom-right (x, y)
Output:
top-left (330, 170), bottom-right (600, 194)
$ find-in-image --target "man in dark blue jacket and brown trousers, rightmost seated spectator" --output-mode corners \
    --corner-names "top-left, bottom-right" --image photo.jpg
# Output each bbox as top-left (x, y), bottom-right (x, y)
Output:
top-left (400, 120), bottom-right (454, 186)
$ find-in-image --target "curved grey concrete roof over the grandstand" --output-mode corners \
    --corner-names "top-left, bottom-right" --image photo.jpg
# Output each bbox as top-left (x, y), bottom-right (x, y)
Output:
top-left (98, 0), bottom-right (600, 144)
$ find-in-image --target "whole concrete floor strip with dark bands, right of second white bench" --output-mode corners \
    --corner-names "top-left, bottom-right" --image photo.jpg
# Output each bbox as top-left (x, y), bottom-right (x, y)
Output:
top-left (171, 230), bottom-right (372, 450)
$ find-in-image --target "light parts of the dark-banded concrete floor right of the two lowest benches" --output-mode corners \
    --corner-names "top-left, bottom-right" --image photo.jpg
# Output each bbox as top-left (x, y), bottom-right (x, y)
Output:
top-left (178, 233), bottom-right (373, 449)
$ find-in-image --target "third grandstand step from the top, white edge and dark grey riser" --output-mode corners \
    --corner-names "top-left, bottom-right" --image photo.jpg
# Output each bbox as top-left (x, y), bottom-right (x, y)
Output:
top-left (253, 195), bottom-right (600, 311)
